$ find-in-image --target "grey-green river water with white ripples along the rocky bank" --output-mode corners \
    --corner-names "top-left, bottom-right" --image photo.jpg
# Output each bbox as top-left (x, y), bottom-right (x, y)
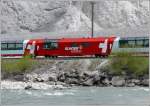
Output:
top-left (1, 87), bottom-right (150, 106)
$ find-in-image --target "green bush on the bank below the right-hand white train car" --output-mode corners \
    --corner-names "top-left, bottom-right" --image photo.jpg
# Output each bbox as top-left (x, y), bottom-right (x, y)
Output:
top-left (109, 52), bottom-right (149, 77)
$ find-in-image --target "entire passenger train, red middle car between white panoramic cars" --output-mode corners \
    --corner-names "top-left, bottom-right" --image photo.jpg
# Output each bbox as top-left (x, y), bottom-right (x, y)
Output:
top-left (1, 36), bottom-right (149, 58)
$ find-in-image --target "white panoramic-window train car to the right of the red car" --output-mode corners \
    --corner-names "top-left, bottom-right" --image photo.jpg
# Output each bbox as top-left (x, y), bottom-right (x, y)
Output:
top-left (112, 37), bottom-right (149, 55)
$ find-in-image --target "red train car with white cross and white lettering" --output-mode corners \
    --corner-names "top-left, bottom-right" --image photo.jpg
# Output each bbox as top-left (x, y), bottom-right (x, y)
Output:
top-left (24, 37), bottom-right (116, 57)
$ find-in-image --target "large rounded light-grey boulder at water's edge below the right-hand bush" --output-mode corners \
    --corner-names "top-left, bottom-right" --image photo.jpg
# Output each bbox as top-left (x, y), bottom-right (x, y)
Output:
top-left (111, 76), bottom-right (125, 87)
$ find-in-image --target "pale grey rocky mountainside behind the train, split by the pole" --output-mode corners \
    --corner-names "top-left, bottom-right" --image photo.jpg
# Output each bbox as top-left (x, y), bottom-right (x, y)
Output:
top-left (0, 0), bottom-right (150, 34)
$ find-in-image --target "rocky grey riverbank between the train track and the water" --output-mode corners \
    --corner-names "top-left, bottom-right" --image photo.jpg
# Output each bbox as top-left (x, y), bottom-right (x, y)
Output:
top-left (2, 58), bottom-right (149, 89)
